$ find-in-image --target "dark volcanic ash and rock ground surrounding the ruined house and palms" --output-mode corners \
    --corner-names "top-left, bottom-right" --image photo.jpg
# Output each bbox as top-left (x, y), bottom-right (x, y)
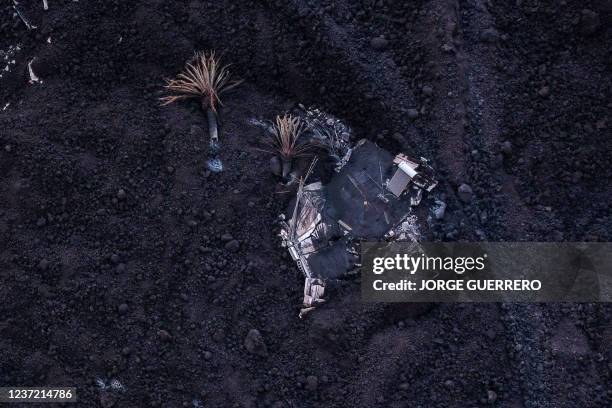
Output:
top-left (0, 0), bottom-right (612, 408)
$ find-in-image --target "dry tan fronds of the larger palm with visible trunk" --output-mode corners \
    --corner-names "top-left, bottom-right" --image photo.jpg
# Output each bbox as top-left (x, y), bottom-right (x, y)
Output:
top-left (160, 51), bottom-right (242, 113)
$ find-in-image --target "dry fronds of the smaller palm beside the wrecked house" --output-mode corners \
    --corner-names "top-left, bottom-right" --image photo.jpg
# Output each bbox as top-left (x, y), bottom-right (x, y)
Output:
top-left (262, 115), bottom-right (315, 160)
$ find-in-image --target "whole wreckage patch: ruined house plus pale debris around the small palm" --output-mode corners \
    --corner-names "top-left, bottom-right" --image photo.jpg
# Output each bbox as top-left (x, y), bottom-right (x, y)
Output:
top-left (254, 106), bottom-right (437, 317)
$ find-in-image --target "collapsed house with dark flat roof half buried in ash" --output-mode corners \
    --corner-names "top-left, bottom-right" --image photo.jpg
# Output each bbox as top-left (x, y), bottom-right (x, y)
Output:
top-left (280, 139), bottom-right (437, 317)
